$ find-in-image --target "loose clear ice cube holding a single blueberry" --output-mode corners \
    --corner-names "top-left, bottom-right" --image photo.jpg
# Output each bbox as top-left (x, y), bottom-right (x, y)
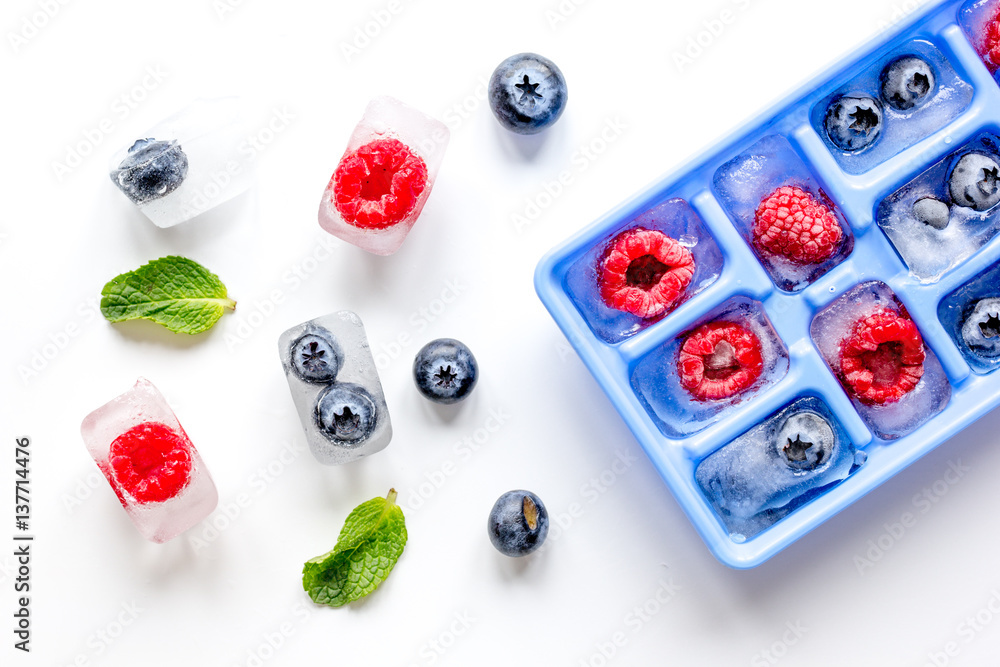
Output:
top-left (111, 98), bottom-right (254, 227)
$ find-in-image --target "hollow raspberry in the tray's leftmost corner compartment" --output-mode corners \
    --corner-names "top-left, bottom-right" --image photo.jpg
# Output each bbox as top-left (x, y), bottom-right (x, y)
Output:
top-left (598, 227), bottom-right (694, 318)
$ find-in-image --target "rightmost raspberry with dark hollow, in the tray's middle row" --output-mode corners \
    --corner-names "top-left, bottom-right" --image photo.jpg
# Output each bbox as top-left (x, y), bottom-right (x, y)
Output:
top-left (840, 308), bottom-right (924, 405)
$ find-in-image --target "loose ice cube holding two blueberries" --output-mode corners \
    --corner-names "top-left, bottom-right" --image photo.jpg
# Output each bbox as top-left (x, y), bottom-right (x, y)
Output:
top-left (278, 310), bottom-right (392, 465)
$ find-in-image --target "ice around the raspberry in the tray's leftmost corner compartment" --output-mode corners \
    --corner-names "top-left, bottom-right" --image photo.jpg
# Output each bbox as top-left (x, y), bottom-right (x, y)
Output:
top-left (566, 198), bottom-right (723, 343)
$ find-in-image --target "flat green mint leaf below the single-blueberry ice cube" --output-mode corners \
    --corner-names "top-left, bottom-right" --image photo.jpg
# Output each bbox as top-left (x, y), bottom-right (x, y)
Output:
top-left (101, 256), bottom-right (236, 334)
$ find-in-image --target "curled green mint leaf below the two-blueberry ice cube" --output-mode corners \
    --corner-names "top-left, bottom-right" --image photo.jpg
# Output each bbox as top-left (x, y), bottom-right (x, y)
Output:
top-left (302, 489), bottom-right (406, 607)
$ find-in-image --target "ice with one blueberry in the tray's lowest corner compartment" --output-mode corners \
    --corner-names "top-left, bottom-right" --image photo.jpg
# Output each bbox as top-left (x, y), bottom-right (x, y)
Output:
top-left (695, 396), bottom-right (866, 542)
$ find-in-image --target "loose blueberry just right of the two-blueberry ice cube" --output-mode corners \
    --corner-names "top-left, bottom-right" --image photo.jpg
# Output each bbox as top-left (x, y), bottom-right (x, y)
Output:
top-left (413, 338), bottom-right (479, 404)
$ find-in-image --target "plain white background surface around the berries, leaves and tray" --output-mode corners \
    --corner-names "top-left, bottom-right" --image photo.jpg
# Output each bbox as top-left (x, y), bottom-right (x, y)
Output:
top-left (0, 0), bottom-right (1000, 667)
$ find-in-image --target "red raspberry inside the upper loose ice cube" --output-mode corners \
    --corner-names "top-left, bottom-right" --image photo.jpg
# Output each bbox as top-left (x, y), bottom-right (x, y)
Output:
top-left (331, 139), bottom-right (427, 229)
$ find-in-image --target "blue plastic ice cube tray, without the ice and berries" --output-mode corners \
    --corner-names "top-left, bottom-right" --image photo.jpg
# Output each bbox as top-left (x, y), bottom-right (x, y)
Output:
top-left (535, 0), bottom-right (1000, 568)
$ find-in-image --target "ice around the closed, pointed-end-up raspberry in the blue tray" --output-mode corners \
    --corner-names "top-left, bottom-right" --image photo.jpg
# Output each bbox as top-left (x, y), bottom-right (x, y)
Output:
top-left (712, 135), bottom-right (854, 292)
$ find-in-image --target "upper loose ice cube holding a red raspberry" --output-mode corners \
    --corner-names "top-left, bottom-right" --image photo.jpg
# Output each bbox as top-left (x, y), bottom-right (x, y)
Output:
top-left (319, 96), bottom-right (451, 255)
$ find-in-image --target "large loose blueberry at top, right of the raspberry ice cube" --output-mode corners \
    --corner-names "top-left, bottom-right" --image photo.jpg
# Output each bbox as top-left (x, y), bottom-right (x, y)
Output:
top-left (489, 53), bottom-right (568, 134)
